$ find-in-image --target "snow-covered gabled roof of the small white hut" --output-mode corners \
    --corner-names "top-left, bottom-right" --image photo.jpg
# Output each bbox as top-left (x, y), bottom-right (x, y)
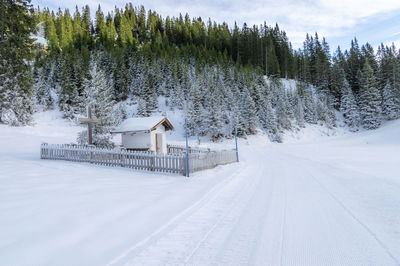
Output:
top-left (112, 116), bottom-right (174, 133)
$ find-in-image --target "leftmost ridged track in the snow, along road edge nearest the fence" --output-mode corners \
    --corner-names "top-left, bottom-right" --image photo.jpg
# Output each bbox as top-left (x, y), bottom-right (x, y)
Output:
top-left (123, 162), bottom-right (256, 265)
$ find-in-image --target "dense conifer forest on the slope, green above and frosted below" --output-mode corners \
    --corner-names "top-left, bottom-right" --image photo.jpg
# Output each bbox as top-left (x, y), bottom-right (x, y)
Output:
top-left (0, 0), bottom-right (400, 146)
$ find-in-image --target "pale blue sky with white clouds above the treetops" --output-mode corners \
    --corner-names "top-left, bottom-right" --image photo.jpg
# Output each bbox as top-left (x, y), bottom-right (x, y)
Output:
top-left (32, 0), bottom-right (400, 51)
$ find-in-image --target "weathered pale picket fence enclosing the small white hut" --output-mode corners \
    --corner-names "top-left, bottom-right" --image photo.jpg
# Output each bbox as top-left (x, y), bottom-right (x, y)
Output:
top-left (40, 143), bottom-right (237, 175)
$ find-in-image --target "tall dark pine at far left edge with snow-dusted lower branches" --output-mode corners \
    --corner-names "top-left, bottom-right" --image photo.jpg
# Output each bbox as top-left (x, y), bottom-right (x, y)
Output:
top-left (0, 0), bottom-right (34, 125)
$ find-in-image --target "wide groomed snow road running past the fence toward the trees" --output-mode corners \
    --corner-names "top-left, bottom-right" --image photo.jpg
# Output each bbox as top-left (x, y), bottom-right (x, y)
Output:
top-left (110, 148), bottom-right (400, 265)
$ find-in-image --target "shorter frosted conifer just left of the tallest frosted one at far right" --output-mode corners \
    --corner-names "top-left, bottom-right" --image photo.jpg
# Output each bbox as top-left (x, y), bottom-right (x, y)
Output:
top-left (340, 80), bottom-right (360, 131)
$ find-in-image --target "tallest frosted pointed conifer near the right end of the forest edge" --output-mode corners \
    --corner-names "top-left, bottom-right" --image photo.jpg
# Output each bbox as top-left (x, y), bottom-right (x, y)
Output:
top-left (359, 61), bottom-right (382, 129)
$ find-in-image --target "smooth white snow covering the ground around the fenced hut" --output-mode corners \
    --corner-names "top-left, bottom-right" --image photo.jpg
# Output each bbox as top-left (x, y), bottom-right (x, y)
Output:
top-left (0, 112), bottom-right (400, 265)
